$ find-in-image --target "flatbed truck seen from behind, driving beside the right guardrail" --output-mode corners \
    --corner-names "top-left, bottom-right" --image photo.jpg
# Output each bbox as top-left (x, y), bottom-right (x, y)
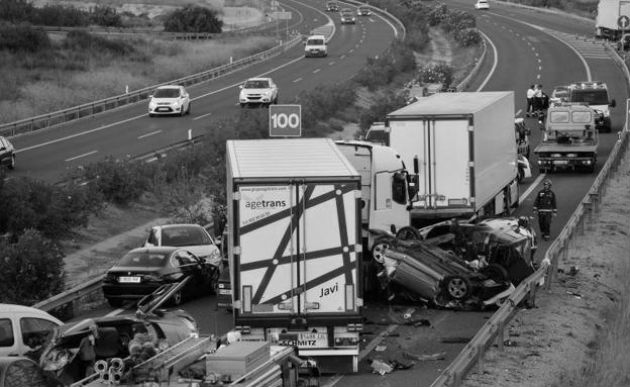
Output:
top-left (534, 104), bottom-right (599, 172)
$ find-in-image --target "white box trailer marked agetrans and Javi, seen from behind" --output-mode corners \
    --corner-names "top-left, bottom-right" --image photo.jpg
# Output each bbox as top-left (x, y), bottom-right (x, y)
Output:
top-left (226, 138), bottom-right (363, 372)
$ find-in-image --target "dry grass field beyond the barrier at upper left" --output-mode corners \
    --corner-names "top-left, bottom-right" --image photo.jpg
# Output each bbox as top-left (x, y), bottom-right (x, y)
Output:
top-left (0, 0), bottom-right (275, 123)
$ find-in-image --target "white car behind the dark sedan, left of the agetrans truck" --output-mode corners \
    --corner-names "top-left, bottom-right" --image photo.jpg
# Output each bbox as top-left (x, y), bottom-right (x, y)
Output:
top-left (143, 224), bottom-right (221, 266)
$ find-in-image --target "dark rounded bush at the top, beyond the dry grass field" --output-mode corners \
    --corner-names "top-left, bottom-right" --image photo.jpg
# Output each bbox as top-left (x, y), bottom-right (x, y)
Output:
top-left (164, 5), bottom-right (223, 33)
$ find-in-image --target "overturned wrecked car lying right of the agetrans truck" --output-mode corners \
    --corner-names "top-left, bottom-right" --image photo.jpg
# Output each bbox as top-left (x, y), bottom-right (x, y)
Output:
top-left (372, 217), bottom-right (537, 309)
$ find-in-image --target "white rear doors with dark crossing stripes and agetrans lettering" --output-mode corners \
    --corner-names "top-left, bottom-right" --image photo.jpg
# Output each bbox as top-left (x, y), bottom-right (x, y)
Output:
top-left (235, 180), bottom-right (360, 321)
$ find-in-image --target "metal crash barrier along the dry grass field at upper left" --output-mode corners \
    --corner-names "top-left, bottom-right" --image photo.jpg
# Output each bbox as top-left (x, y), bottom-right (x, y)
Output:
top-left (0, 36), bottom-right (301, 137)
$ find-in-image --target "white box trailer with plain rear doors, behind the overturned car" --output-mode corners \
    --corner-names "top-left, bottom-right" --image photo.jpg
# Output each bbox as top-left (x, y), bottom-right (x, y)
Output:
top-left (386, 91), bottom-right (518, 225)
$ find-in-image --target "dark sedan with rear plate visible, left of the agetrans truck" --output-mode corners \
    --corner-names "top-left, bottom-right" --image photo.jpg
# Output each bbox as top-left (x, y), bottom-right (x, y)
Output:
top-left (103, 247), bottom-right (219, 307)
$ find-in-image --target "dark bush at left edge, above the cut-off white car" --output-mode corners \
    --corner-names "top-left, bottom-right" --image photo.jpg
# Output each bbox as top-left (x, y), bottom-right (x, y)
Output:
top-left (0, 230), bottom-right (64, 305)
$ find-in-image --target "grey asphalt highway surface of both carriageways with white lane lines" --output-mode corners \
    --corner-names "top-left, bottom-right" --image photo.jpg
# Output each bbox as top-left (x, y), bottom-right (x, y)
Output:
top-left (7, 0), bottom-right (628, 386)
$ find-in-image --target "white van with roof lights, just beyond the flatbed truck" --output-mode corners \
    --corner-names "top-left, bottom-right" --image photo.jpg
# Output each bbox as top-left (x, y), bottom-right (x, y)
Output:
top-left (567, 81), bottom-right (617, 132)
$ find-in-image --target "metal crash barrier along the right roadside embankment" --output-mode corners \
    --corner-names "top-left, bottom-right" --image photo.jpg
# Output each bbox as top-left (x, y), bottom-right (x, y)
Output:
top-left (431, 47), bottom-right (630, 387)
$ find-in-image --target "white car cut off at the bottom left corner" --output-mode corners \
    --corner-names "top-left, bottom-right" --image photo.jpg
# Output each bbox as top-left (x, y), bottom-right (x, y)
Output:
top-left (0, 304), bottom-right (63, 356)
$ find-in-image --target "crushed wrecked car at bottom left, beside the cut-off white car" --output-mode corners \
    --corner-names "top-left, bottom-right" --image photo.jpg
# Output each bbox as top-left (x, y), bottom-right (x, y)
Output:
top-left (40, 280), bottom-right (199, 385)
